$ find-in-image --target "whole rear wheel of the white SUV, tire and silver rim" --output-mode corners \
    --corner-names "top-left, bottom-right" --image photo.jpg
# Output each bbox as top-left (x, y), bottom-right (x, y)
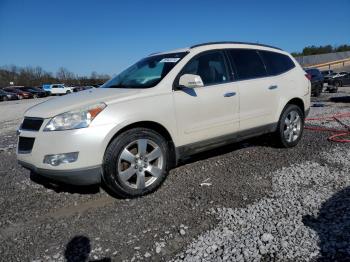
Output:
top-left (275, 104), bottom-right (305, 148)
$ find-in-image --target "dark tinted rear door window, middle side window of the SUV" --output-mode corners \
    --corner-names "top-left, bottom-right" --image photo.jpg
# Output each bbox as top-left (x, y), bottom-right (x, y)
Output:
top-left (229, 49), bottom-right (267, 80)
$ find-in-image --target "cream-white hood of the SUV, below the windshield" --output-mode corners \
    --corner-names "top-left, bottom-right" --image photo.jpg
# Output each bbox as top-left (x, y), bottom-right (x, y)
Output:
top-left (24, 88), bottom-right (141, 118)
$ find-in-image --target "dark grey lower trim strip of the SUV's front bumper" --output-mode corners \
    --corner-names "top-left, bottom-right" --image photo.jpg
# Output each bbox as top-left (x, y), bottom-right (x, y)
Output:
top-left (18, 160), bottom-right (102, 186)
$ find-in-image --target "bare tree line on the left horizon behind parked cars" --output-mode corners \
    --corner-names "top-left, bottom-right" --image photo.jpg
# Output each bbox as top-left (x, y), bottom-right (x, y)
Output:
top-left (0, 65), bottom-right (110, 87)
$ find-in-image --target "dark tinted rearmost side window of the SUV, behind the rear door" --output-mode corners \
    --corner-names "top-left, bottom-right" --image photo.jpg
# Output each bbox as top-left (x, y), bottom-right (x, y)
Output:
top-left (259, 51), bottom-right (296, 75)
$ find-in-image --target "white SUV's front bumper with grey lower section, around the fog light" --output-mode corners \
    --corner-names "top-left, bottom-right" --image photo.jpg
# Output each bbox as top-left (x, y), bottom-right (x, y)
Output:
top-left (17, 119), bottom-right (115, 185)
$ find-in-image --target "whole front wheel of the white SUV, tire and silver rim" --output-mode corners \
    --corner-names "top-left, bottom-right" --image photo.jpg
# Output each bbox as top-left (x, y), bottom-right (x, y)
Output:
top-left (102, 128), bottom-right (170, 198)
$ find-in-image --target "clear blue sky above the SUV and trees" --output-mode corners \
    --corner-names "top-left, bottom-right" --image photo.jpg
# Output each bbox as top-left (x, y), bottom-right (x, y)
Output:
top-left (0, 0), bottom-right (350, 75)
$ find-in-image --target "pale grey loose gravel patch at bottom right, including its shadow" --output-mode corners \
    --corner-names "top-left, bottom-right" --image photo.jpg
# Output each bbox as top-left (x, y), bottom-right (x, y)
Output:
top-left (172, 147), bottom-right (350, 261)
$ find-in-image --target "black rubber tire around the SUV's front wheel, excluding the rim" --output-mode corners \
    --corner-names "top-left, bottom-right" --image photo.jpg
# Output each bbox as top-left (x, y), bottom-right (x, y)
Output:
top-left (102, 128), bottom-right (170, 198)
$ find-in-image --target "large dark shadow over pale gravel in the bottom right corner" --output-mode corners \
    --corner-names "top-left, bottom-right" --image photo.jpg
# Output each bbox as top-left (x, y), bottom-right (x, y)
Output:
top-left (303, 187), bottom-right (350, 262)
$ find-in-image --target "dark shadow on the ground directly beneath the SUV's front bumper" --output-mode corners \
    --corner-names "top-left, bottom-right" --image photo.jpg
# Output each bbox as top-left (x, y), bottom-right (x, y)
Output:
top-left (30, 172), bottom-right (100, 195)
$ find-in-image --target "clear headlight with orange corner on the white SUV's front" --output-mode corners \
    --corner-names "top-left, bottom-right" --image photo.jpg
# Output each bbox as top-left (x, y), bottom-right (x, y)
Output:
top-left (44, 103), bottom-right (107, 131)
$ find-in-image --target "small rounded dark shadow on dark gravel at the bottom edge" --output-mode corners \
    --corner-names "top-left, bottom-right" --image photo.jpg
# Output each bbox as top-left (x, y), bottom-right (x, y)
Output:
top-left (64, 236), bottom-right (112, 262)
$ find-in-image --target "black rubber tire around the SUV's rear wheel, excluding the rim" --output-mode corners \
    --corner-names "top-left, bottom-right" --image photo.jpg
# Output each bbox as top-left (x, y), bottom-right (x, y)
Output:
top-left (276, 104), bottom-right (305, 148)
